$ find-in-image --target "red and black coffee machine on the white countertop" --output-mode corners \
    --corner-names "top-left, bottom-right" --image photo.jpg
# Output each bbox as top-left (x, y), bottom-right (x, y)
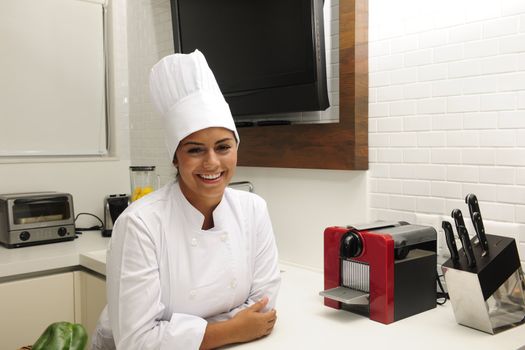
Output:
top-left (319, 221), bottom-right (437, 324)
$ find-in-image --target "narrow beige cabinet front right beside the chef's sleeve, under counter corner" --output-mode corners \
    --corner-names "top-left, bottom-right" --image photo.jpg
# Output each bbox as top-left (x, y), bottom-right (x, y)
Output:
top-left (76, 271), bottom-right (106, 344)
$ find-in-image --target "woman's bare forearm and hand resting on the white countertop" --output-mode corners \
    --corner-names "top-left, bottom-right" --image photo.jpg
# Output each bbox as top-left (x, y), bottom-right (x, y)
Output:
top-left (200, 297), bottom-right (277, 350)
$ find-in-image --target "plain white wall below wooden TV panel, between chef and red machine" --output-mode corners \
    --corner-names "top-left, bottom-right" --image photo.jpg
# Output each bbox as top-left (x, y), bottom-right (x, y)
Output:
top-left (234, 166), bottom-right (368, 269)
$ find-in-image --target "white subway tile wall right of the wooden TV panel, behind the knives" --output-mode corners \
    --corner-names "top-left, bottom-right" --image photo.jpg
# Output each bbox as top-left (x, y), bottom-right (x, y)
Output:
top-left (369, 0), bottom-right (525, 263)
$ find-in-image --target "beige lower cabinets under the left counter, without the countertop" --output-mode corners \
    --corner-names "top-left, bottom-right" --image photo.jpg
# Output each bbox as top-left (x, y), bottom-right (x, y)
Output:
top-left (0, 271), bottom-right (106, 350)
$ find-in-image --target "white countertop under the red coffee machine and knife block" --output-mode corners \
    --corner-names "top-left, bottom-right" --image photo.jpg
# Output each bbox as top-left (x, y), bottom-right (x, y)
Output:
top-left (256, 265), bottom-right (525, 350)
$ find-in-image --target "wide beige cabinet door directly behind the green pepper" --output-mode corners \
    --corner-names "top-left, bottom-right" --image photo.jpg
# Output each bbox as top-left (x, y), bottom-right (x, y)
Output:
top-left (0, 272), bottom-right (75, 350)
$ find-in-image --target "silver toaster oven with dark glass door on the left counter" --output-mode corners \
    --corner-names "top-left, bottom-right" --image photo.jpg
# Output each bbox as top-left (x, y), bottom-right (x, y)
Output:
top-left (0, 192), bottom-right (76, 248)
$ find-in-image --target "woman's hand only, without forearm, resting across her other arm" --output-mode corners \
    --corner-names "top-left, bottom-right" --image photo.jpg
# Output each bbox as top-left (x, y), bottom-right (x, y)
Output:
top-left (231, 297), bottom-right (277, 342)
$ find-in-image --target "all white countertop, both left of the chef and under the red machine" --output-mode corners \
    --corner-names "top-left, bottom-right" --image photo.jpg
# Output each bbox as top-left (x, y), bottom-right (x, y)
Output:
top-left (0, 232), bottom-right (525, 350)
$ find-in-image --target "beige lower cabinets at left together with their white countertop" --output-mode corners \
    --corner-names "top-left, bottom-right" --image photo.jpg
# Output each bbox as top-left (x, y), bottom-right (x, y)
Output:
top-left (0, 231), bottom-right (109, 350)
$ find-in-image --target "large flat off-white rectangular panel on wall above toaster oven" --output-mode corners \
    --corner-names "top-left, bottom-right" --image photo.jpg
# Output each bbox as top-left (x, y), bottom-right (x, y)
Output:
top-left (0, 0), bottom-right (107, 157)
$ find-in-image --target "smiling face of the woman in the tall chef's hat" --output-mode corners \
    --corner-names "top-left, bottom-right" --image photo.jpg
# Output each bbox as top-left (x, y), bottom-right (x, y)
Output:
top-left (173, 127), bottom-right (237, 208)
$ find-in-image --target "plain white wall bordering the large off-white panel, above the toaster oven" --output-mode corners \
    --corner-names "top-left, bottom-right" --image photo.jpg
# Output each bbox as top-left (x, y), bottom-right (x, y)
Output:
top-left (0, 0), bottom-right (130, 227)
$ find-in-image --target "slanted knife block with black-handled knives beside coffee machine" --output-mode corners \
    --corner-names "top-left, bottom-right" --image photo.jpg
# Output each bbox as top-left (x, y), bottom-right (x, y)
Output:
top-left (441, 194), bottom-right (525, 334)
